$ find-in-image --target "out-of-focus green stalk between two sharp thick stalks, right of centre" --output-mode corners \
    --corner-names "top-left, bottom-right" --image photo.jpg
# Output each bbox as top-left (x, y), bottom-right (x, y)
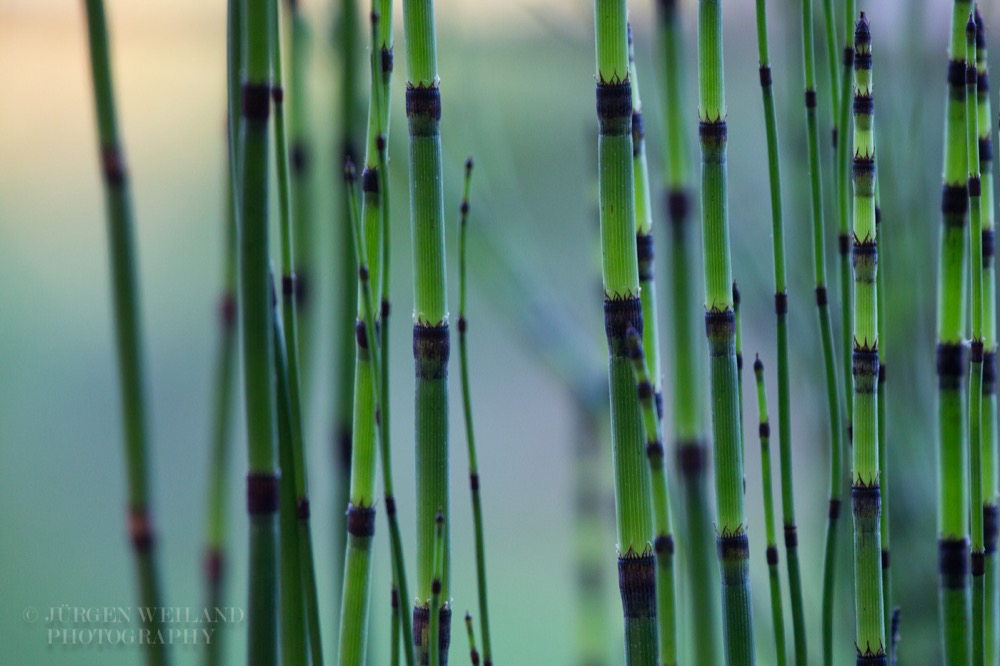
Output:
top-left (659, 0), bottom-right (721, 666)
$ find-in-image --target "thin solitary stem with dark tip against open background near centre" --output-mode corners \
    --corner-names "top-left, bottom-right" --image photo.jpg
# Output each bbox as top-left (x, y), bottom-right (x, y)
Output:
top-left (458, 157), bottom-right (493, 666)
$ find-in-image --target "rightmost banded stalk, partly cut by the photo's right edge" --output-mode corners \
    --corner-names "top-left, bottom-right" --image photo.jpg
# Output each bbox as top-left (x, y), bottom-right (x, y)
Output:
top-left (976, 6), bottom-right (1000, 664)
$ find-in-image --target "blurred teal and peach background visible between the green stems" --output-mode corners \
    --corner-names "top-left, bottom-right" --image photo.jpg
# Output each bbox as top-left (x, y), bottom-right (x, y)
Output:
top-left (0, 0), bottom-right (984, 664)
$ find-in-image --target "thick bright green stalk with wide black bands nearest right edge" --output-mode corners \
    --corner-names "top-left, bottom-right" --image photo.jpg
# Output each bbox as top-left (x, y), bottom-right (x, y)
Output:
top-left (937, 0), bottom-right (971, 664)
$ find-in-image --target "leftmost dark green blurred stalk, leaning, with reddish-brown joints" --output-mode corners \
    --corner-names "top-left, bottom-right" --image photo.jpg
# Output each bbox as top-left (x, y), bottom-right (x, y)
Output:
top-left (86, 5), bottom-right (168, 664)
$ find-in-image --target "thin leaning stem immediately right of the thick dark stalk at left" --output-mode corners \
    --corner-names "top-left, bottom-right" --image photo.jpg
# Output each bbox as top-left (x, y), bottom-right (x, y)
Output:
top-left (271, 2), bottom-right (323, 663)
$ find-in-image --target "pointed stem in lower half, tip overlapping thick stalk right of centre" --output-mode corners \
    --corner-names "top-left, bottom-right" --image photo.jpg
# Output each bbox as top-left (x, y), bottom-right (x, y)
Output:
top-left (626, 328), bottom-right (678, 666)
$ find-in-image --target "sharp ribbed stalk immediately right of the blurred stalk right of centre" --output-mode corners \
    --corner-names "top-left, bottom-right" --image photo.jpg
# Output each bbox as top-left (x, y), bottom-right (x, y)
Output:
top-left (698, 0), bottom-right (754, 666)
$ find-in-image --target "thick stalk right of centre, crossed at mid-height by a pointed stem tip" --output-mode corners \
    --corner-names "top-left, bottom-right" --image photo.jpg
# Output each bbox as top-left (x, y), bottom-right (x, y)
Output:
top-left (594, 0), bottom-right (657, 666)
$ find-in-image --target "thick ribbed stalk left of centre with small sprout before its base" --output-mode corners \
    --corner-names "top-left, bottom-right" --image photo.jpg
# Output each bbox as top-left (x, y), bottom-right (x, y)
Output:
top-left (403, 0), bottom-right (451, 666)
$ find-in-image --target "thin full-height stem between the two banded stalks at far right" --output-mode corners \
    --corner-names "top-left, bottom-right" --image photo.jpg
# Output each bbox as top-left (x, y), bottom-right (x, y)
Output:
top-left (965, 13), bottom-right (986, 666)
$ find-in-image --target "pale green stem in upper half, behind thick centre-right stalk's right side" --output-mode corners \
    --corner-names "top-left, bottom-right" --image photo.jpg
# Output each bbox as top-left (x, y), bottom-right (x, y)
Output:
top-left (628, 25), bottom-right (663, 419)
